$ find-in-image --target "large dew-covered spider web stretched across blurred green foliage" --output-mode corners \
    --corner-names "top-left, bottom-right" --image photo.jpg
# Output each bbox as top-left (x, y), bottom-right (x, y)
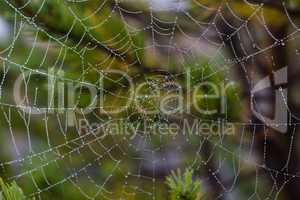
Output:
top-left (0, 0), bottom-right (299, 199)
